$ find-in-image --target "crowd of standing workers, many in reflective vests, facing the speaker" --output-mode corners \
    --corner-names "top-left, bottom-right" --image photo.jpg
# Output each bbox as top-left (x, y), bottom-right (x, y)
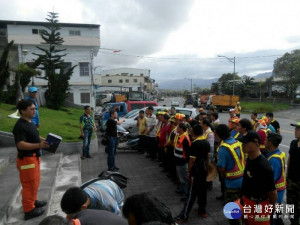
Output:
top-left (137, 105), bottom-right (300, 224)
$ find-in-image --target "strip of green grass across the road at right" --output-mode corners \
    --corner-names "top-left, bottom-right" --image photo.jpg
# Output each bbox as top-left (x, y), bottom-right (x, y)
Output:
top-left (241, 101), bottom-right (290, 113)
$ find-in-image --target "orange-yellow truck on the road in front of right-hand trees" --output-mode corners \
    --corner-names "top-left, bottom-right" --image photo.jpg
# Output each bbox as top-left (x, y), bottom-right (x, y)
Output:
top-left (211, 95), bottom-right (240, 112)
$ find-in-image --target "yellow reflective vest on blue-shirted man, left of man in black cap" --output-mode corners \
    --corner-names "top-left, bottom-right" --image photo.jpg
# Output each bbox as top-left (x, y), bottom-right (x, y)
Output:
top-left (221, 141), bottom-right (245, 179)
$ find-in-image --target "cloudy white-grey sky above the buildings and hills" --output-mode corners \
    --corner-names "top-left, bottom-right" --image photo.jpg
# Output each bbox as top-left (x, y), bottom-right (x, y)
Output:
top-left (0, 0), bottom-right (300, 81)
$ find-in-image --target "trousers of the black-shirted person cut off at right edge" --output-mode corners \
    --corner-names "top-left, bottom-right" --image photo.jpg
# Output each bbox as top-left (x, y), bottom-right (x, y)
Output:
top-left (286, 179), bottom-right (300, 225)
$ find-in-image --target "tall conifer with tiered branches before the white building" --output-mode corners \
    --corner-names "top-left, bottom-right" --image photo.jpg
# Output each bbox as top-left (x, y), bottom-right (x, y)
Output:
top-left (33, 12), bottom-right (75, 109)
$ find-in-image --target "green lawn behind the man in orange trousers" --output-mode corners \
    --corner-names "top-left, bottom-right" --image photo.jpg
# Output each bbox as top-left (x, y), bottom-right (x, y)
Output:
top-left (0, 103), bottom-right (88, 142)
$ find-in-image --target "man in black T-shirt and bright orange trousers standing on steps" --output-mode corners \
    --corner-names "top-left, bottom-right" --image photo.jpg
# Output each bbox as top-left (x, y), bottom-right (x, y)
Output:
top-left (13, 99), bottom-right (50, 220)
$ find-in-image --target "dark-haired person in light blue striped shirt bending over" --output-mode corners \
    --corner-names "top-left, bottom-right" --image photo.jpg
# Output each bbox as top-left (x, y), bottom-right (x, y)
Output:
top-left (60, 180), bottom-right (124, 218)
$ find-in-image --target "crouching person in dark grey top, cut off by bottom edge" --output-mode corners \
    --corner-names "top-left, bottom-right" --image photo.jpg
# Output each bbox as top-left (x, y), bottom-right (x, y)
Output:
top-left (39, 209), bottom-right (127, 225)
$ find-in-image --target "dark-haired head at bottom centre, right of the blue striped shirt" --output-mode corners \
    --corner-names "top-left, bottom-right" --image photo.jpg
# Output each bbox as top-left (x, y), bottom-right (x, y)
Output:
top-left (123, 193), bottom-right (175, 225)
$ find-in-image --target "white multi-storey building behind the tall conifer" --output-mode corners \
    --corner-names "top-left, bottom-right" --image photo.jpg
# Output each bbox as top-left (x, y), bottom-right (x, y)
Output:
top-left (0, 20), bottom-right (100, 106)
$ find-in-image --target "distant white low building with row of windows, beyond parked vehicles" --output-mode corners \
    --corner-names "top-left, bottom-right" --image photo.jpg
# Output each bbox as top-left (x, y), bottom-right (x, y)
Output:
top-left (95, 68), bottom-right (155, 93)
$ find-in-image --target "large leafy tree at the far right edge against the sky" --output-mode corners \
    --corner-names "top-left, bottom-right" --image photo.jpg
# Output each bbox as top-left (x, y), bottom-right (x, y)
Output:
top-left (273, 49), bottom-right (300, 98)
